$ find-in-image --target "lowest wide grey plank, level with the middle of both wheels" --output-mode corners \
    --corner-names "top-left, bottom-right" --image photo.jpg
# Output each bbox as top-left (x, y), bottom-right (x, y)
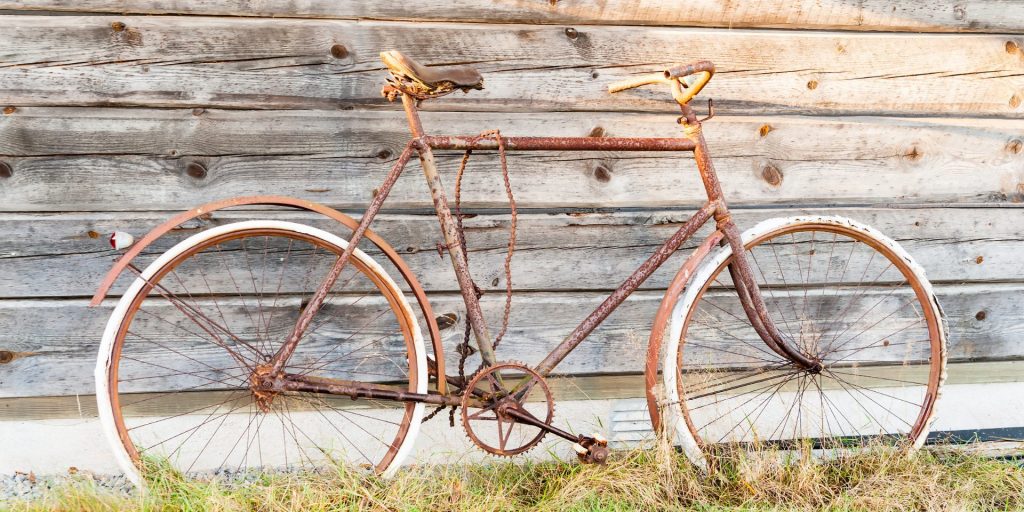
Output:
top-left (0, 285), bottom-right (1024, 397)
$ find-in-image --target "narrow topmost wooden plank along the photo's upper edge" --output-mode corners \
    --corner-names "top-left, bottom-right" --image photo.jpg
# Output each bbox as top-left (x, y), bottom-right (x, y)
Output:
top-left (0, 0), bottom-right (1024, 32)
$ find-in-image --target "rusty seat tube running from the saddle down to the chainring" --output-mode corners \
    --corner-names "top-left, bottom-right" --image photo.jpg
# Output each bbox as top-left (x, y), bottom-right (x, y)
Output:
top-left (401, 94), bottom-right (495, 365)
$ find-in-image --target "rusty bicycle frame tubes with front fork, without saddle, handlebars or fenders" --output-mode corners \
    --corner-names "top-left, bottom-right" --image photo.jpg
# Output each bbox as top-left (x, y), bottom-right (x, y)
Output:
top-left (270, 88), bottom-right (820, 403)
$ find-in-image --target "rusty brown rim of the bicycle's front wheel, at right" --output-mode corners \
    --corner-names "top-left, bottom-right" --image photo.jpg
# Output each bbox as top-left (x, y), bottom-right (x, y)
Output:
top-left (676, 223), bottom-right (944, 449)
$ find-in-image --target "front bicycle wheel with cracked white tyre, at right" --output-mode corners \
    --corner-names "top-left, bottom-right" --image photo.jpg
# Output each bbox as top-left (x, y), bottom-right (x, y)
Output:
top-left (662, 217), bottom-right (946, 467)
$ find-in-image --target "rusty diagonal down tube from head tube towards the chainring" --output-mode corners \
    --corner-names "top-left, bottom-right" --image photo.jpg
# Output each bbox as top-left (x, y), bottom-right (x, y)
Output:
top-left (536, 202), bottom-right (718, 377)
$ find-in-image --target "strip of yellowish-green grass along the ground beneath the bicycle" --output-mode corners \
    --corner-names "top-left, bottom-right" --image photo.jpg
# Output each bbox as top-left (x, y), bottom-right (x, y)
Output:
top-left (6, 447), bottom-right (1024, 512)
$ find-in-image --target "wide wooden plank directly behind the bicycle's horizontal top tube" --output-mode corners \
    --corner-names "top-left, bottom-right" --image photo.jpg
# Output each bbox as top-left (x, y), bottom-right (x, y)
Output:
top-left (0, 108), bottom-right (1024, 211)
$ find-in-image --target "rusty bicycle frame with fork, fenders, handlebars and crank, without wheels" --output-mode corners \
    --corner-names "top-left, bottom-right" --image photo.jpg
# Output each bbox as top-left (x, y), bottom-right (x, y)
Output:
top-left (93, 60), bottom-right (822, 454)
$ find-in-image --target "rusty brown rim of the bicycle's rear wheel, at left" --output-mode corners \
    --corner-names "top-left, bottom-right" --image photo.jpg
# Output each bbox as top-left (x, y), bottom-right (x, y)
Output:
top-left (109, 228), bottom-right (419, 473)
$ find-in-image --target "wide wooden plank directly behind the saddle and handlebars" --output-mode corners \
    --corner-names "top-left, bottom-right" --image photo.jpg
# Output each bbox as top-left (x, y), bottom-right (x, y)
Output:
top-left (0, 15), bottom-right (1024, 116)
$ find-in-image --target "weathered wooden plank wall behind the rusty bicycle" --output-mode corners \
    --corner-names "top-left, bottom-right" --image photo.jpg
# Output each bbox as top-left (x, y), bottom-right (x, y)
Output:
top-left (0, 0), bottom-right (1024, 409)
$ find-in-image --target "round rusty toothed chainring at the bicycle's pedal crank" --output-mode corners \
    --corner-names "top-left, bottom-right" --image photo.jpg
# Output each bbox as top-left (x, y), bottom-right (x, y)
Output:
top-left (461, 361), bottom-right (555, 457)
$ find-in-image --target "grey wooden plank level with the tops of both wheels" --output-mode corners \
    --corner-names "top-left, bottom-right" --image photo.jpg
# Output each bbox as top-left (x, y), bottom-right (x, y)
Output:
top-left (0, 208), bottom-right (1024, 298)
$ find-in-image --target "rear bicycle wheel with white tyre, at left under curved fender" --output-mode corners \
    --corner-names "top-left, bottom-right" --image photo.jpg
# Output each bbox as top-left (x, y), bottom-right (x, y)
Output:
top-left (96, 220), bottom-right (427, 481)
